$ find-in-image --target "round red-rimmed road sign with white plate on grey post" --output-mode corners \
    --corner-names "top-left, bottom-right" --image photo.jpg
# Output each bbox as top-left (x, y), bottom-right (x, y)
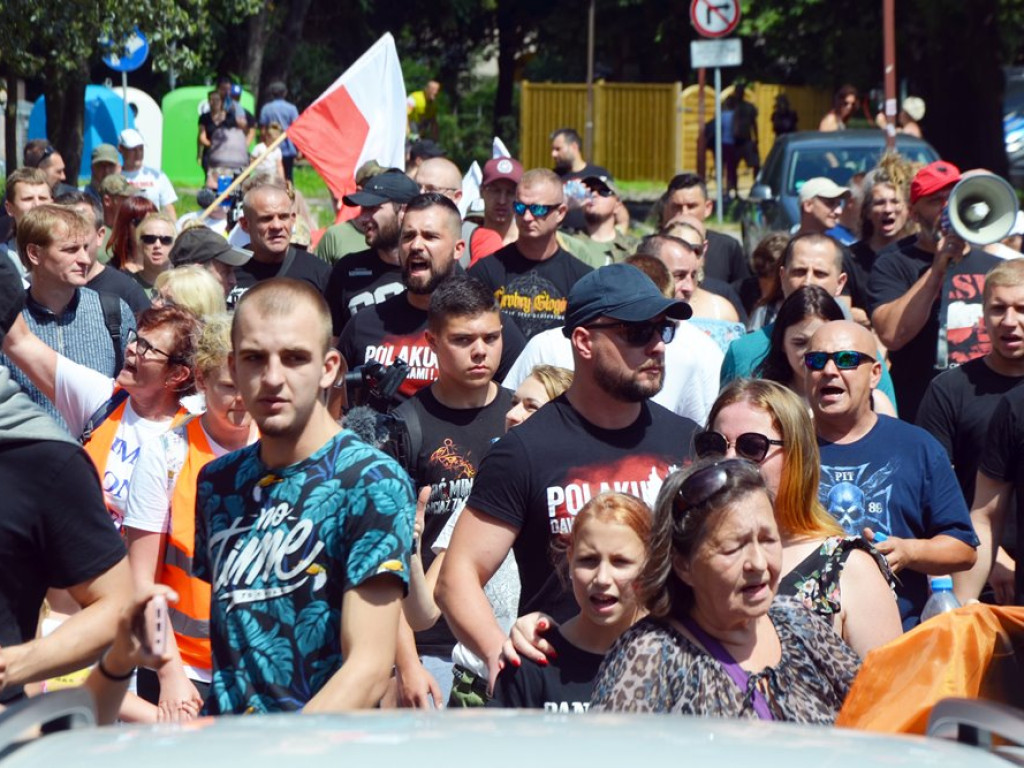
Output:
top-left (690, 0), bottom-right (743, 223)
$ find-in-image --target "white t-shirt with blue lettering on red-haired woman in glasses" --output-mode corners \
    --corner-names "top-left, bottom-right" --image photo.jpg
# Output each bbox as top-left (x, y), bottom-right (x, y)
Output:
top-left (54, 355), bottom-right (172, 527)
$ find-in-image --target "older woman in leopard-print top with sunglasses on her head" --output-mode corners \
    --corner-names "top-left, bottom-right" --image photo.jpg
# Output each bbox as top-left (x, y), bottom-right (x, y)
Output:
top-left (591, 459), bottom-right (859, 724)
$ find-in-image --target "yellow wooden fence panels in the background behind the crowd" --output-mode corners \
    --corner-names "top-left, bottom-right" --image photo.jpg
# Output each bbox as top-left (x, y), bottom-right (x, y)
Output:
top-left (519, 81), bottom-right (831, 183)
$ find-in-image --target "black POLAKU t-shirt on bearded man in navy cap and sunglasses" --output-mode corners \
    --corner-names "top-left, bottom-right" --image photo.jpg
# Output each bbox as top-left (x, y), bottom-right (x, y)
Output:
top-left (469, 395), bottom-right (697, 622)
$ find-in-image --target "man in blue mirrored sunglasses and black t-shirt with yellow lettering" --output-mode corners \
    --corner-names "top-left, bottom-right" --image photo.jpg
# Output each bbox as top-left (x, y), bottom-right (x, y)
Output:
top-left (468, 168), bottom-right (591, 339)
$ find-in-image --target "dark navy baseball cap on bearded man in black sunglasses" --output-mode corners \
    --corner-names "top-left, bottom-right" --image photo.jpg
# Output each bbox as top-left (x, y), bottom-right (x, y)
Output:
top-left (562, 264), bottom-right (693, 337)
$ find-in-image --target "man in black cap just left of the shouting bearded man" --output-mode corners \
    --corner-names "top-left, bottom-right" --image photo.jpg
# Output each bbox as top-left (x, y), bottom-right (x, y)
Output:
top-left (325, 168), bottom-right (423, 336)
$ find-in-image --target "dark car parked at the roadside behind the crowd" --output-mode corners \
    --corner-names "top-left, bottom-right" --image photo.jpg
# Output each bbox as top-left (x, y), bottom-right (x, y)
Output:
top-left (740, 130), bottom-right (939, 253)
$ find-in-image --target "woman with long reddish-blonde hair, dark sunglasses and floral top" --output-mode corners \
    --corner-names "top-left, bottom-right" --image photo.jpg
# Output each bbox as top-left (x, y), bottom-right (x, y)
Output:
top-left (694, 379), bottom-right (902, 655)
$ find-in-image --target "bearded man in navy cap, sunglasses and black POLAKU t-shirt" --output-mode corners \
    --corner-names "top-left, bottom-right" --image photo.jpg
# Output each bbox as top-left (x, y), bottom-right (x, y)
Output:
top-left (436, 264), bottom-right (697, 683)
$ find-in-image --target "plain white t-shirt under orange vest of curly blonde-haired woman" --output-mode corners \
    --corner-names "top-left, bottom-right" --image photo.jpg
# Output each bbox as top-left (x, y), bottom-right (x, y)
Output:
top-left (125, 424), bottom-right (227, 534)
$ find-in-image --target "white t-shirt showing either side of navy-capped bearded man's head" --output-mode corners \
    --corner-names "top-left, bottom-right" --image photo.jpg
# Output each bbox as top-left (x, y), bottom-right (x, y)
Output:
top-left (502, 321), bottom-right (725, 425)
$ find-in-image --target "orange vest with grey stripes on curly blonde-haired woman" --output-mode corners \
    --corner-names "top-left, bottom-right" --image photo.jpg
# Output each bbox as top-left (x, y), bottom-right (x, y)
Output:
top-left (157, 418), bottom-right (214, 670)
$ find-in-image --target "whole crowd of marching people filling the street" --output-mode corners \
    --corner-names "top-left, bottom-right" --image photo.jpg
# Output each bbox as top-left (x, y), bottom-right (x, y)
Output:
top-left (0, 84), bottom-right (1024, 724)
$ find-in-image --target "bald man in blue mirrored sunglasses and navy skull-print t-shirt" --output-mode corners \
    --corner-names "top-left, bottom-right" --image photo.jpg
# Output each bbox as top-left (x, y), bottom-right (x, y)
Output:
top-left (804, 321), bottom-right (978, 630)
